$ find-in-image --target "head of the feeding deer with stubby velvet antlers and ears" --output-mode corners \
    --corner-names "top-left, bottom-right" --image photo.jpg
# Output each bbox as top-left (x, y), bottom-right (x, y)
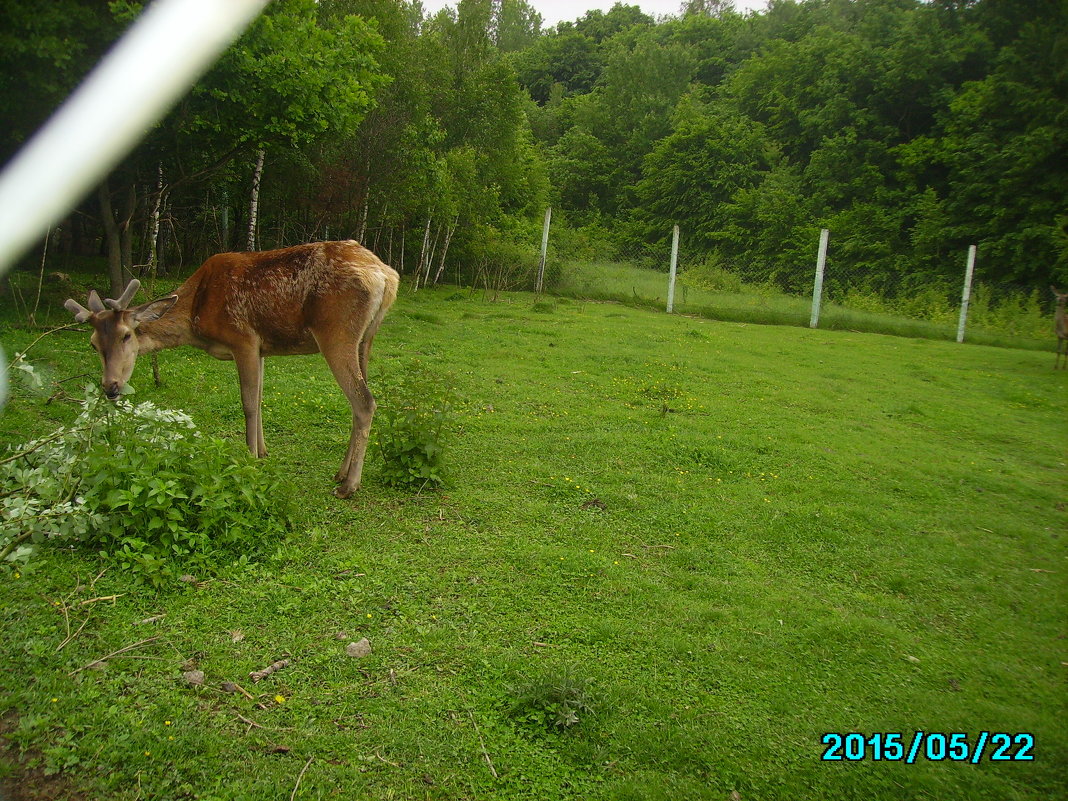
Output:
top-left (63, 279), bottom-right (178, 401)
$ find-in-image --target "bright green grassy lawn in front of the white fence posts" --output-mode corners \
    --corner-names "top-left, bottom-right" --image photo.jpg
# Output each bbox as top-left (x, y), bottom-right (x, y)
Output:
top-left (0, 279), bottom-right (1068, 801)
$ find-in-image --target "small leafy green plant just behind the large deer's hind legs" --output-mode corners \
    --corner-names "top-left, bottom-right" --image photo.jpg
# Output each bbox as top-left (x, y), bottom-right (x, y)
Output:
top-left (375, 364), bottom-right (452, 491)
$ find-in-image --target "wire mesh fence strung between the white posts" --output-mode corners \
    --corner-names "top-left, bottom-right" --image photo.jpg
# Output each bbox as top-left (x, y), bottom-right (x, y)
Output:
top-left (546, 213), bottom-right (1055, 349)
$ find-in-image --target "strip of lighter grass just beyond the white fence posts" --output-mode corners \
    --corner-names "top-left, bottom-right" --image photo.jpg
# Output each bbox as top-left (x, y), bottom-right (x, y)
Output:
top-left (554, 262), bottom-right (1056, 350)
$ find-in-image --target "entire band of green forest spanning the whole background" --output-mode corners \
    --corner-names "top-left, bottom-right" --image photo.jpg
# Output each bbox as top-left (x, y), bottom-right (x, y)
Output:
top-left (0, 0), bottom-right (1068, 301)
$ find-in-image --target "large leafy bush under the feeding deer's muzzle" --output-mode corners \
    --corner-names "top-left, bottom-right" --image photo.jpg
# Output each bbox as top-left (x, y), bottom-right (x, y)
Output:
top-left (0, 390), bottom-right (288, 586)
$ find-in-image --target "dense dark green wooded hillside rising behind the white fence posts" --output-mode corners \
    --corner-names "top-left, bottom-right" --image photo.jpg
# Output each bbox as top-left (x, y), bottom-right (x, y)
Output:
top-left (520, 0), bottom-right (1068, 293)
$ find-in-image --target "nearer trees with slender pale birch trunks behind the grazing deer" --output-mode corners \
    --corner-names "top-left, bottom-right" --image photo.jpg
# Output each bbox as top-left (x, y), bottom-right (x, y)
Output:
top-left (0, 0), bottom-right (549, 292)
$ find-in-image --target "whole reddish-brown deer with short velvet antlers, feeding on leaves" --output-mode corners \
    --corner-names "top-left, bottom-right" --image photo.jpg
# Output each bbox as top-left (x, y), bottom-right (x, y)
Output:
top-left (64, 240), bottom-right (399, 498)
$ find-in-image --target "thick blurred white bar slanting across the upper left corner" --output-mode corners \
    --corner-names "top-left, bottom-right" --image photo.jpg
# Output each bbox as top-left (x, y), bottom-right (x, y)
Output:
top-left (0, 0), bottom-right (267, 272)
